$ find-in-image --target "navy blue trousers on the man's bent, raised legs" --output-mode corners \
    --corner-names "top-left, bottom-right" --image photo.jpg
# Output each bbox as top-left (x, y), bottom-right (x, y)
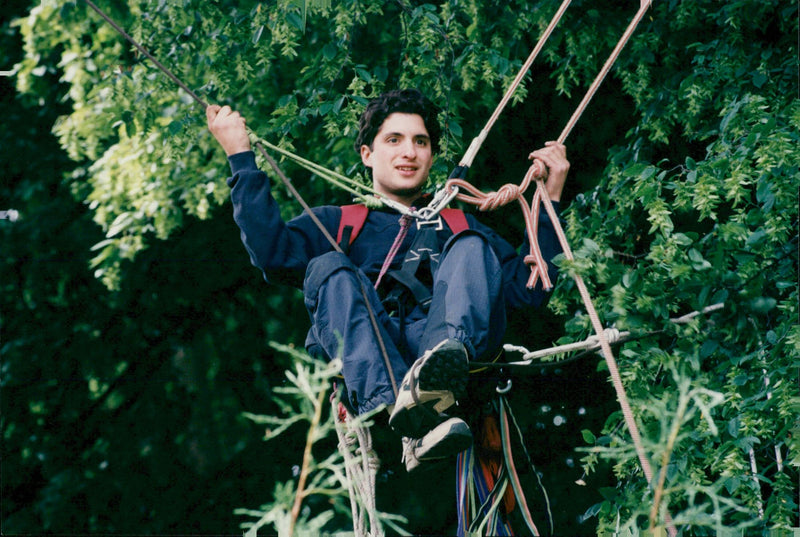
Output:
top-left (303, 230), bottom-right (506, 414)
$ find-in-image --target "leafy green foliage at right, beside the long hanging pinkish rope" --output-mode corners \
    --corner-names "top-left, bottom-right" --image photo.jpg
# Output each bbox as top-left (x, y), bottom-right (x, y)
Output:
top-left (556, 51), bottom-right (800, 534)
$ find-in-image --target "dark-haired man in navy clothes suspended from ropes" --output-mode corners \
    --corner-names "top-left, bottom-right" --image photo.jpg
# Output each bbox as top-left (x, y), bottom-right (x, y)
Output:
top-left (206, 90), bottom-right (569, 470)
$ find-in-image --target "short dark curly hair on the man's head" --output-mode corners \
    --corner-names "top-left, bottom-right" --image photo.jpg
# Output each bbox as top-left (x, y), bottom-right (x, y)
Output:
top-left (354, 89), bottom-right (442, 153)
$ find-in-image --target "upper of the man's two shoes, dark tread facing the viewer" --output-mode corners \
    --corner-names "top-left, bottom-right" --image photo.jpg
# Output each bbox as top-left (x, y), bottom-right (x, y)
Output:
top-left (389, 339), bottom-right (469, 438)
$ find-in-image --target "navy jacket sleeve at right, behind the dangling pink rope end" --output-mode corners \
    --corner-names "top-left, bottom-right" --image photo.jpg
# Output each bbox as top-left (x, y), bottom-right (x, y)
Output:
top-left (468, 202), bottom-right (561, 309)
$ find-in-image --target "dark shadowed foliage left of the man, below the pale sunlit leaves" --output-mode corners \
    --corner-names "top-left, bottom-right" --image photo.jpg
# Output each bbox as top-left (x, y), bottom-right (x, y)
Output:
top-left (0, 2), bottom-right (316, 535)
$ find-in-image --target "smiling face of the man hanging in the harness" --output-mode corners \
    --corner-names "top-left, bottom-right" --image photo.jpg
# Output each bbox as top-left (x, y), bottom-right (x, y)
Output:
top-left (361, 112), bottom-right (433, 205)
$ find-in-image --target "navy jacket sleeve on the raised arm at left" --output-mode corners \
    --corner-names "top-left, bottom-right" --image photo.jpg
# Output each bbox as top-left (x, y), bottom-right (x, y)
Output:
top-left (228, 151), bottom-right (341, 288)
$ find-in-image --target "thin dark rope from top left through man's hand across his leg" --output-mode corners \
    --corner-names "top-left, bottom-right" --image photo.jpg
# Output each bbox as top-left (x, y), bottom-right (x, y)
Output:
top-left (84, 0), bottom-right (398, 397)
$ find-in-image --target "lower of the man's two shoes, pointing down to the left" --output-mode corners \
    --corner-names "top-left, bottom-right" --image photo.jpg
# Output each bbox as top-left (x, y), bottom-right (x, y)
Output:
top-left (403, 418), bottom-right (472, 472)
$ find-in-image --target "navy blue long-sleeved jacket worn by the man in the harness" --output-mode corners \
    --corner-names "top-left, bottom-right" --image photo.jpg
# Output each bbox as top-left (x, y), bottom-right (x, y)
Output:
top-left (228, 151), bottom-right (561, 308)
